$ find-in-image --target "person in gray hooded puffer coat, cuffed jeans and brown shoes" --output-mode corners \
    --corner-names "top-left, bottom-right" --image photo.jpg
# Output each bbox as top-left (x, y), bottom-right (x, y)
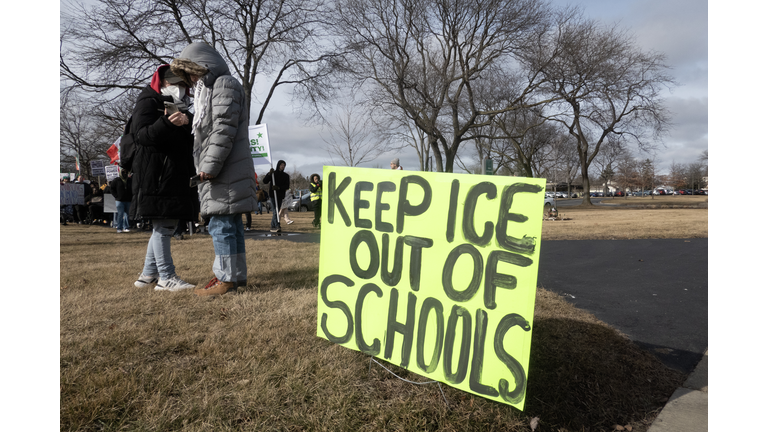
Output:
top-left (171, 42), bottom-right (258, 296)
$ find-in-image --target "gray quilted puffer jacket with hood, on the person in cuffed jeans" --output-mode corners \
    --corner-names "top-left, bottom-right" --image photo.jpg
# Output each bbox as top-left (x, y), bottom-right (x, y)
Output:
top-left (179, 42), bottom-right (258, 217)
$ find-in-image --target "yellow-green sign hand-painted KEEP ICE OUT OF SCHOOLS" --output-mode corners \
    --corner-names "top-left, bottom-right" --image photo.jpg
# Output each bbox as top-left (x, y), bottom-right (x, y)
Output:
top-left (317, 166), bottom-right (545, 410)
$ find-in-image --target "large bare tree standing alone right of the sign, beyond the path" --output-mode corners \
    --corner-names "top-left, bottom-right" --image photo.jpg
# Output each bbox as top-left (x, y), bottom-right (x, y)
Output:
top-left (543, 13), bottom-right (673, 205)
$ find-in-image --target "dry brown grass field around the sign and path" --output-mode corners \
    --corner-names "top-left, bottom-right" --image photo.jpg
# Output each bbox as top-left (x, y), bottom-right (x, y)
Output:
top-left (60, 206), bottom-right (707, 431)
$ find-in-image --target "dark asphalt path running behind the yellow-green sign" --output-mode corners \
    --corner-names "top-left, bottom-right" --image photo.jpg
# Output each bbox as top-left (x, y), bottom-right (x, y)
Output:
top-left (246, 231), bottom-right (709, 373)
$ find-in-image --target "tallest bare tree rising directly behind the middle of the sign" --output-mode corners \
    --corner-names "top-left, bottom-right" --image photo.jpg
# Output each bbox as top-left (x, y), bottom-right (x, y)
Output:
top-left (336, 0), bottom-right (548, 172)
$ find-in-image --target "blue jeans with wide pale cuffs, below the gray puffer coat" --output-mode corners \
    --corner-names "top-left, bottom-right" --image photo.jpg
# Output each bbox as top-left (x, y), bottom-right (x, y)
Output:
top-left (208, 214), bottom-right (248, 283)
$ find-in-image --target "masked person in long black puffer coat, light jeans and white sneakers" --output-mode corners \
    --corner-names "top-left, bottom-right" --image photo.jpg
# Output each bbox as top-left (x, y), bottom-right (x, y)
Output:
top-left (131, 64), bottom-right (197, 291)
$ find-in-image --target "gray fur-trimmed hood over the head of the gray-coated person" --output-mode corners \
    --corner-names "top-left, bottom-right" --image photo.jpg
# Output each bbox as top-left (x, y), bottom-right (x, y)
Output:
top-left (171, 42), bottom-right (230, 87)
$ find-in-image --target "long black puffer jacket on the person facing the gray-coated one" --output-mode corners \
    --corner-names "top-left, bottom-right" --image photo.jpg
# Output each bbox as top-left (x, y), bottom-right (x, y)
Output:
top-left (131, 65), bottom-right (199, 220)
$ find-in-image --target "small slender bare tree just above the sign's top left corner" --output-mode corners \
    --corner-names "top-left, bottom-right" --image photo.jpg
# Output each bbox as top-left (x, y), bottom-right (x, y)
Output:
top-left (323, 104), bottom-right (384, 167)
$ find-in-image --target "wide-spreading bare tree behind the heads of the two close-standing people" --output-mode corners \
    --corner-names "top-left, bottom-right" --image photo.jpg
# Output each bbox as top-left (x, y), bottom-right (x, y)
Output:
top-left (59, 0), bottom-right (339, 124)
